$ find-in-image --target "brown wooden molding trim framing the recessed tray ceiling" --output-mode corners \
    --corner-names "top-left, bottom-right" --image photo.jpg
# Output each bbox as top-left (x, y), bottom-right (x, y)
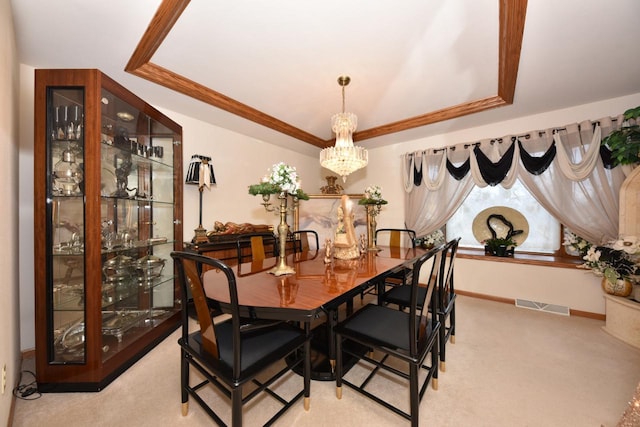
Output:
top-left (125, 0), bottom-right (527, 148)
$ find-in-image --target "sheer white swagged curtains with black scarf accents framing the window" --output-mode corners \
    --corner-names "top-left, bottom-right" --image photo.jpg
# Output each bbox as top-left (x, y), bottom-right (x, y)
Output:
top-left (402, 116), bottom-right (625, 243)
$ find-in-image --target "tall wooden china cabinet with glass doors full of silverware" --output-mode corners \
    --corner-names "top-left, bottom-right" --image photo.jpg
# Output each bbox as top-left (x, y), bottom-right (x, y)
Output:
top-left (34, 69), bottom-right (182, 392)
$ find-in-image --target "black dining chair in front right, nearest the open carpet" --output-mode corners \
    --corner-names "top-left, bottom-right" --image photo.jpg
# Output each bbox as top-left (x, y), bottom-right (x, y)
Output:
top-left (335, 247), bottom-right (442, 426)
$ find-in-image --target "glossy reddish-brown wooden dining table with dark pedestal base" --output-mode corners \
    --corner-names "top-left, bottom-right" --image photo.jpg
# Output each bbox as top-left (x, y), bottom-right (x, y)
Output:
top-left (203, 247), bottom-right (426, 381)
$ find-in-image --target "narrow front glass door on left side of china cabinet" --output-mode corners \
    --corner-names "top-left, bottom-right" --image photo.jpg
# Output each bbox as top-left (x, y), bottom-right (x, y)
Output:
top-left (46, 88), bottom-right (85, 363)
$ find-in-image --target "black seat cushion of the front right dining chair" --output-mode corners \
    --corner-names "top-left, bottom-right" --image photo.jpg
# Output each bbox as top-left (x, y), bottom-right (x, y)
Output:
top-left (335, 304), bottom-right (431, 355)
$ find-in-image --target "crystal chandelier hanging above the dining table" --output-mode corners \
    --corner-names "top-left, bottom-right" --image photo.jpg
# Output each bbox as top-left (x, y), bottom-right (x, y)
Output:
top-left (320, 76), bottom-right (369, 182)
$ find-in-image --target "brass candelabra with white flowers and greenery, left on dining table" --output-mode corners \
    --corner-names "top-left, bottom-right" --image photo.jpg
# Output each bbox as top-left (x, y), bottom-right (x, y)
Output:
top-left (249, 162), bottom-right (309, 276)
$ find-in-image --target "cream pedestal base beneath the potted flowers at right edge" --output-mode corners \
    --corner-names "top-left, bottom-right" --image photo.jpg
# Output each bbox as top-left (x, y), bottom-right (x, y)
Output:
top-left (603, 295), bottom-right (640, 348)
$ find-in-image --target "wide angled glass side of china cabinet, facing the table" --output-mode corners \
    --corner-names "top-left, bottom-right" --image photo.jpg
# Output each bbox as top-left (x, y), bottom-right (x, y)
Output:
top-left (100, 89), bottom-right (178, 360)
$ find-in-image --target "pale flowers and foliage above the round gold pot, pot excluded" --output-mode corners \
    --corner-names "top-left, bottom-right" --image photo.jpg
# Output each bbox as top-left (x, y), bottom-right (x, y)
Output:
top-left (580, 237), bottom-right (640, 283)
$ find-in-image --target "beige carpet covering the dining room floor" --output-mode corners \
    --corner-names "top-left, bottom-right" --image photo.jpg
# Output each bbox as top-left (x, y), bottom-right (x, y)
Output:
top-left (13, 296), bottom-right (640, 427)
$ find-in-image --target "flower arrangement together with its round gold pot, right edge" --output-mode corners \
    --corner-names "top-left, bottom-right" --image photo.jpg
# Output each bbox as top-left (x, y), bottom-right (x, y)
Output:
top-left (580, 237), bottom-right (640, 297)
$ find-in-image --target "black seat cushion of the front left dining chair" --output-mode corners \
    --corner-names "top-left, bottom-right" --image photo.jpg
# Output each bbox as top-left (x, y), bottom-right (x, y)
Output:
top-left (189, 320), bottom-right (305, 377)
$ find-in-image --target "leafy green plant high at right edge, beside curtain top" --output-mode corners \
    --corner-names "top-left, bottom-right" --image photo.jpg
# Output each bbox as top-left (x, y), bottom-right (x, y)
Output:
top-left (602, 106), bottom-right (640, 166)
